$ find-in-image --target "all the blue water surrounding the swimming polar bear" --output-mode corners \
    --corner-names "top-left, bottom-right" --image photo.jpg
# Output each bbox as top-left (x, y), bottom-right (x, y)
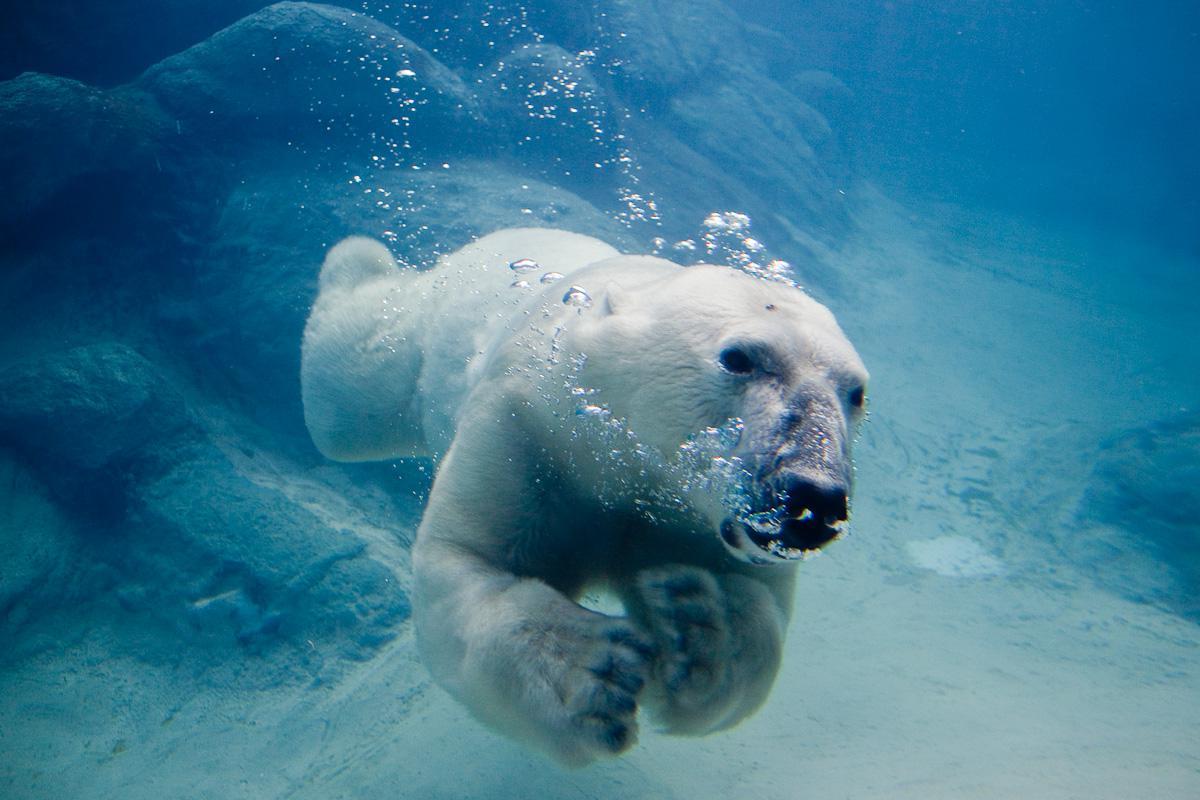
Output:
top-left (0, 0), bottom-right (1200, 799)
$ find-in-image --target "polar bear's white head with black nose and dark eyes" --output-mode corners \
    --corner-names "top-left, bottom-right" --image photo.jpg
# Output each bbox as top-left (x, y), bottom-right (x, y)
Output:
top-left (574, 262), bottom-right (868, 564)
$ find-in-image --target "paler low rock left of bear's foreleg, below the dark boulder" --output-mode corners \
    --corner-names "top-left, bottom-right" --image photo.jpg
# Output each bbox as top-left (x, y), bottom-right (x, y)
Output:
top-left (133, 445), bottom-right (409, 660)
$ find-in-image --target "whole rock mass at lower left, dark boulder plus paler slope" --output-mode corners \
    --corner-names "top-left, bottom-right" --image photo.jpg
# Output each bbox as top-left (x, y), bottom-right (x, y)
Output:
top-left (0, 342), bottom-right (409, 669)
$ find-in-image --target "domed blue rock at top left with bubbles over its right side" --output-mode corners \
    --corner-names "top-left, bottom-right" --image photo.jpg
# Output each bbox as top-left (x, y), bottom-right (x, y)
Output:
top-left (136, 2), bottom-right (478, 148)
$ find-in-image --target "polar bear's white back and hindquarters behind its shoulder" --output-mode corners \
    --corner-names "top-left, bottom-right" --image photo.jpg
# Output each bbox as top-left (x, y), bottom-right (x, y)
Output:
top-left (300, 228), bottom-right (619, 461)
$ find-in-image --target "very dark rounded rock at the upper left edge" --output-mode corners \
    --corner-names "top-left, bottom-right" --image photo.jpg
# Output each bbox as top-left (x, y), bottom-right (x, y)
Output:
top-left (0, 72), bottom-right (168, 225)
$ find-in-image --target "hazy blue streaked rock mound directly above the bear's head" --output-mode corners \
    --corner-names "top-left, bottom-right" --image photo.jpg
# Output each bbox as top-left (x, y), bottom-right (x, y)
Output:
top-left (625, 65), bottom-right (850, 262)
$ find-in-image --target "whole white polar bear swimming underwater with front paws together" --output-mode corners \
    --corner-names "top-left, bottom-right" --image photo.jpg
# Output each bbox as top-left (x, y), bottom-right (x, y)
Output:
top-left (301, 229), bottom-right (868, 765)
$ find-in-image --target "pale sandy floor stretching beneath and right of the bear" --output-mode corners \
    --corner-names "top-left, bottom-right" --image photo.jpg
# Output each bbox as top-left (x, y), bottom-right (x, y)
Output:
top-left (0, 192), bottom-right (1200, 800)
